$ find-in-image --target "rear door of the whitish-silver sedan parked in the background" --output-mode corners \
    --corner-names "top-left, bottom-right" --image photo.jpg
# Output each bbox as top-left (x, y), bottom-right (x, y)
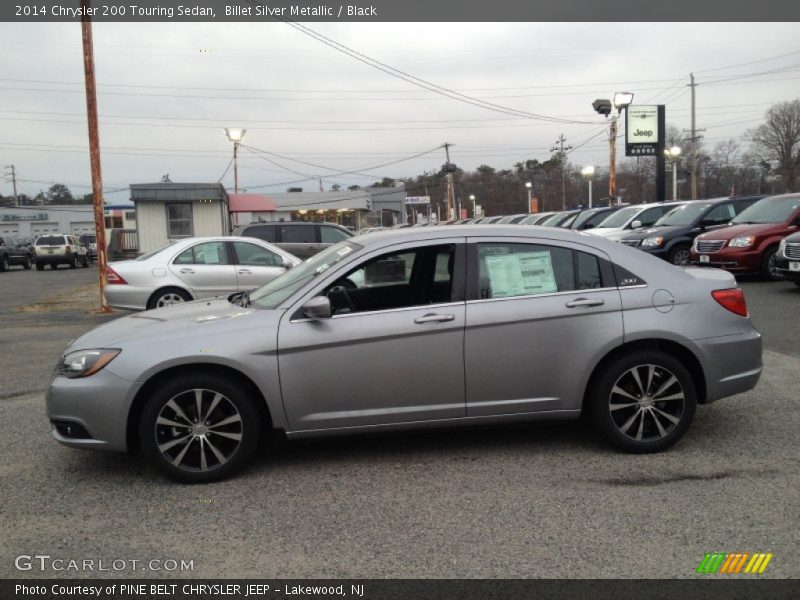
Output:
top-left (169, 241), bottom-right (237, 298)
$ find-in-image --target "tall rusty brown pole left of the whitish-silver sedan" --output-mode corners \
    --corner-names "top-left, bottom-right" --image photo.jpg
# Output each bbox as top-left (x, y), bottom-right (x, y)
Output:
top-left (81, 0), bottom-right (111, 312)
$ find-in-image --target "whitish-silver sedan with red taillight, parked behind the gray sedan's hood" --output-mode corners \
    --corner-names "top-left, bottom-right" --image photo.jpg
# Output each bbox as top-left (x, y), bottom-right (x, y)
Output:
top-left (105, 236), bottom-right (302, 310)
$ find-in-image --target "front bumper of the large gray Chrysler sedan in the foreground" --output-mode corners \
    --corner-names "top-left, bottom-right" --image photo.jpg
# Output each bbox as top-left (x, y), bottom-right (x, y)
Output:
top-left (45, 369), bottom-right (141, 452)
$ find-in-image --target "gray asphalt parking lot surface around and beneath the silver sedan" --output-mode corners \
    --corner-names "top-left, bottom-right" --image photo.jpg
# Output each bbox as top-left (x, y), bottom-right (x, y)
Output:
top-left (0, 268), bottom-right (800, 578)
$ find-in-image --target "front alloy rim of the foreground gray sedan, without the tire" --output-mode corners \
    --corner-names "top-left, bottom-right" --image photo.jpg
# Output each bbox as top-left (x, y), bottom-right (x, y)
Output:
top-left (155, 389), bottom-right (243, 472)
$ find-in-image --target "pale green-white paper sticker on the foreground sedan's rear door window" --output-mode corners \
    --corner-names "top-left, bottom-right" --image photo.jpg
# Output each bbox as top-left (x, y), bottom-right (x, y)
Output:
top-left (485, 251), bottom-right (558, 298)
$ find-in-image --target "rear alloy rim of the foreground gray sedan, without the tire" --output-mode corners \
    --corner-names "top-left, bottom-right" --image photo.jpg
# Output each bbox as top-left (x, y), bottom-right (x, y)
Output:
top-left (608, 364), bottom-right (686, 442)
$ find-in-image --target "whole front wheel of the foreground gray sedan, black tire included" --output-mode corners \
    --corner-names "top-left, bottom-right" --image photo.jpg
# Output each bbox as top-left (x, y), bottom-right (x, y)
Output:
top-left (139, 372), bottom-right (261, 483)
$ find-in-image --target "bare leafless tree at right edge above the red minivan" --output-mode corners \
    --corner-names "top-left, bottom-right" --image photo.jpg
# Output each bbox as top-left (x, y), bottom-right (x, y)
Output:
top-left (745, 99), bottom-right (800, 192)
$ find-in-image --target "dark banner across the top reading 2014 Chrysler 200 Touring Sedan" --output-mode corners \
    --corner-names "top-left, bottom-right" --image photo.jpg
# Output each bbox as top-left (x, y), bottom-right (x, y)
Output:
top-left (0, 0), bottom-right (798, 22)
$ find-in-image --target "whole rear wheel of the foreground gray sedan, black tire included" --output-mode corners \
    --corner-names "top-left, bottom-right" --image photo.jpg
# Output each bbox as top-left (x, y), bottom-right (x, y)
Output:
top-left (588, 350), bottom-right (697, 454)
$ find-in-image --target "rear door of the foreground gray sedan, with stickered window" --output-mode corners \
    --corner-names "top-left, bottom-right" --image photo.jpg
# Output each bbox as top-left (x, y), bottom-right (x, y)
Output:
top-left (464, 238), bottom-right (623, 417)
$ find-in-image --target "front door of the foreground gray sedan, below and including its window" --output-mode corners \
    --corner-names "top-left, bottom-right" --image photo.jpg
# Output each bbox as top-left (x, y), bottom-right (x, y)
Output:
top-left (278, 238), bottom-right (465, 432)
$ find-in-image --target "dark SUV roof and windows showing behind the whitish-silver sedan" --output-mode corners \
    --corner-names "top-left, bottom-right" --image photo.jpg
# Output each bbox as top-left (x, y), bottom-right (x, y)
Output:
top-left (233, 221), bottom-right (353, 260)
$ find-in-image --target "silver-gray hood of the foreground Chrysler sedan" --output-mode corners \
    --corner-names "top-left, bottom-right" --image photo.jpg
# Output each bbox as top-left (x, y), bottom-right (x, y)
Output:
top-left (67, 298), bottom-right (268, 351)
